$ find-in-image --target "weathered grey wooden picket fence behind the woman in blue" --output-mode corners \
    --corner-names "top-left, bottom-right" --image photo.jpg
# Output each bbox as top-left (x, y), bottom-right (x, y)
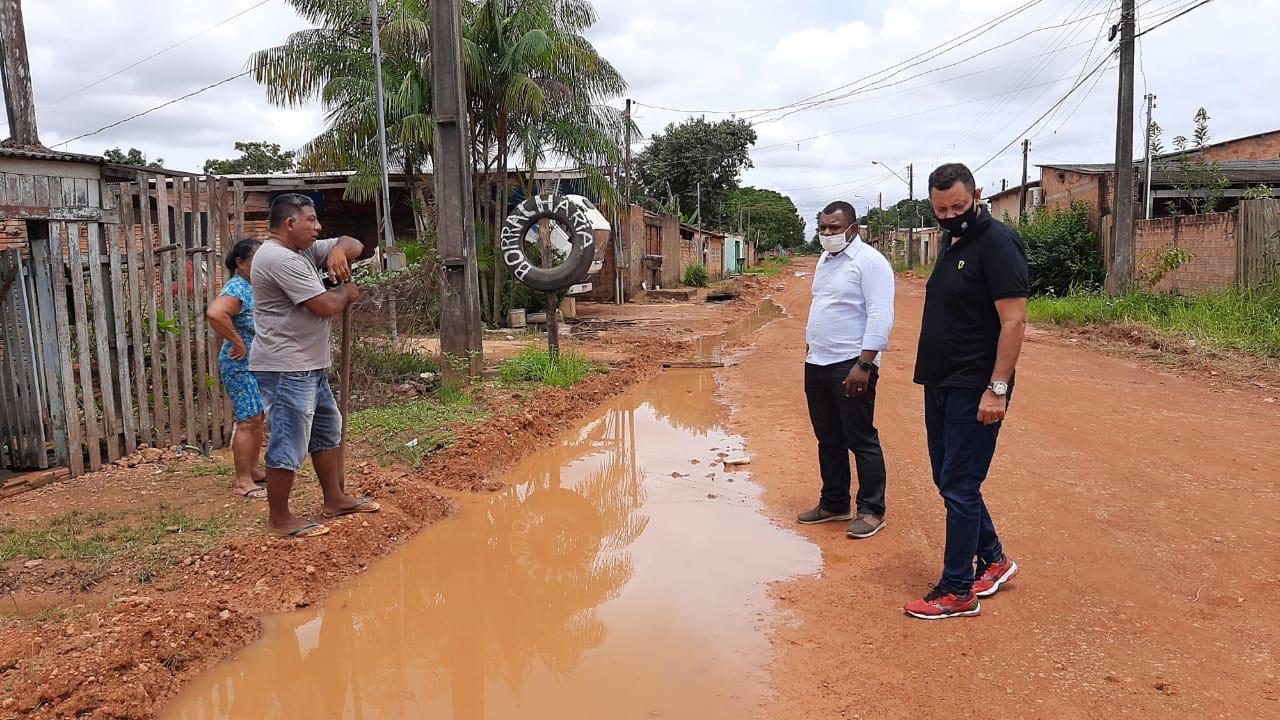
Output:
top-left (0, 173), bottom-right (243, 475)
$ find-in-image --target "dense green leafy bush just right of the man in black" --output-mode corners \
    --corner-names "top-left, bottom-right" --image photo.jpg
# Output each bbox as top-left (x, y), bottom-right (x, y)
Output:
top-left (1012, 202), bottom-right (1106, 297)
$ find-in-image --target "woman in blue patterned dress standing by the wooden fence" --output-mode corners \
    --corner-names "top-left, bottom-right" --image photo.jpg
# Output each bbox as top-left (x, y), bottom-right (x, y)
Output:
top-left (206, 240), bottom-right (266, 500)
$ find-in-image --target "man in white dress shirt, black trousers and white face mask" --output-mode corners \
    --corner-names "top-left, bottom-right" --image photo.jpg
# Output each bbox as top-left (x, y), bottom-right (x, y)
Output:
top-left (796, 201), bottom-right (893, 538)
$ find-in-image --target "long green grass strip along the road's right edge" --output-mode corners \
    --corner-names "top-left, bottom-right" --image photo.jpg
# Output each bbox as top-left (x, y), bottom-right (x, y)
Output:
top-left (1028, 288), bottom-right (1280, 359)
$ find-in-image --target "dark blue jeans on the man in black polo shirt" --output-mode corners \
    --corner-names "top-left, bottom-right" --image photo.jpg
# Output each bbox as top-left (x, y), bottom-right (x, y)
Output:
top-left (924, 386), bottom-right (1011, 594)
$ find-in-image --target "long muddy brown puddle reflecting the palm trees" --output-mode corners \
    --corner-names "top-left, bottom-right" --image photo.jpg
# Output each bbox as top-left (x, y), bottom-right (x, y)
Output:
top-left (163, 304), bottom-right (820, 720)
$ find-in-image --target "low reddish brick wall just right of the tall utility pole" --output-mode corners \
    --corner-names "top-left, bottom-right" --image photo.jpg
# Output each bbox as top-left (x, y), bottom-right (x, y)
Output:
top-left (1134, 213), bottom-right (1236, 292)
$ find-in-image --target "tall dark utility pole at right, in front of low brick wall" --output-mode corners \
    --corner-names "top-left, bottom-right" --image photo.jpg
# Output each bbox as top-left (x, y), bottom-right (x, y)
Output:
top-left (1107, 0), bottom-right (1135, 296)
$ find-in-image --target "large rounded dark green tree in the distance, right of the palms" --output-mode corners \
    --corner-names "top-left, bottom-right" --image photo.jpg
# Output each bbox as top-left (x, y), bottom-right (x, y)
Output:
top-left (640, 118), bottom-right (755, 227)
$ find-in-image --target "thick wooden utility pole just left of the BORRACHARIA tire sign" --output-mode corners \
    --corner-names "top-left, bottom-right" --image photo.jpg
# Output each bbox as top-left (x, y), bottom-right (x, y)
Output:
top-left (431, 0), bottom-right (484, 379)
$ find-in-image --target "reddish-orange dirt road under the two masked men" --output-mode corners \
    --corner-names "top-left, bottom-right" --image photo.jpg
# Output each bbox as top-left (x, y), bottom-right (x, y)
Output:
top-left (722, 254), bottom-right (1280, 719)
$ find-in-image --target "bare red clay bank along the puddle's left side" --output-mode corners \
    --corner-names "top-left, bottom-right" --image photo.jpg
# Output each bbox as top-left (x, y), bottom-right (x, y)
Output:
top-left (0, 274), bottom-right (765, 720)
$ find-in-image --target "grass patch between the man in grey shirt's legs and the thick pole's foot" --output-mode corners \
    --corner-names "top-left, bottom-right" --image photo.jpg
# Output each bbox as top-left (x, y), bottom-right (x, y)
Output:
top-left (348, 383), bottom-right (489, 468)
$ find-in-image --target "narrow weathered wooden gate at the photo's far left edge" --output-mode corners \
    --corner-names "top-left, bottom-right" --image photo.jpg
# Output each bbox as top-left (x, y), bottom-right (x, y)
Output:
top-left (0, 250), bottom-right (49, 469)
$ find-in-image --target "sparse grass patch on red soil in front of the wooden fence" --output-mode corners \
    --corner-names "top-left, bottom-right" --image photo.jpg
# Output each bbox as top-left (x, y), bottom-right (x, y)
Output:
top-left (0, 506), bottom-right (232, 566)
